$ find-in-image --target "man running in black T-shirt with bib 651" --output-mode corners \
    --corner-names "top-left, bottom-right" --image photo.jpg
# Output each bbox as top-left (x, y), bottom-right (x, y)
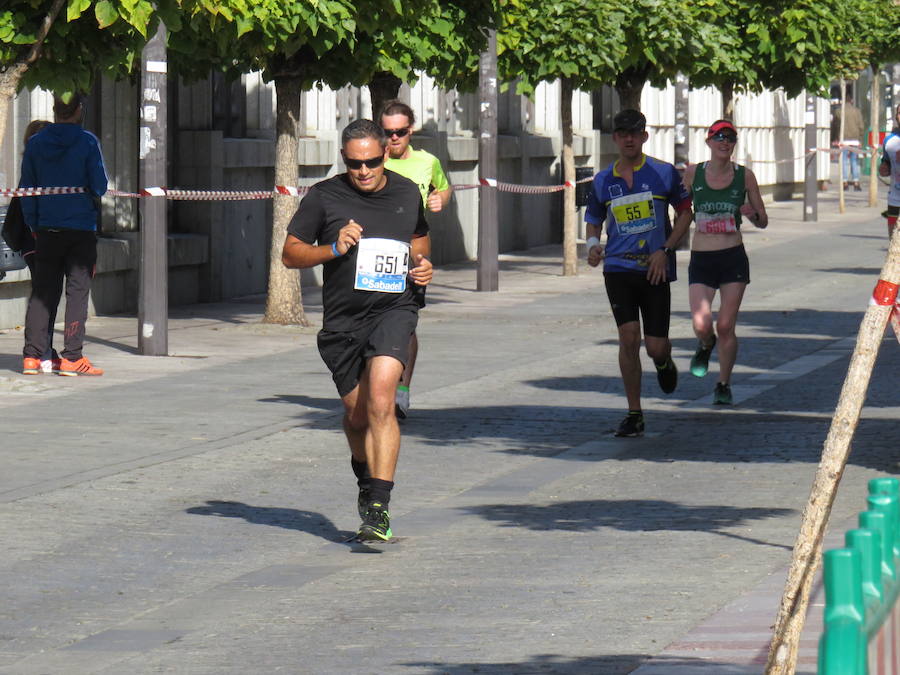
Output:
top-left (282, 119), bottom-right (432, 541)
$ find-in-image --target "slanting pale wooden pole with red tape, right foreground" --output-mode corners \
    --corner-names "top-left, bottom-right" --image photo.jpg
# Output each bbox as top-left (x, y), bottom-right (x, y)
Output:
top-left (765, 227), bottom-right (900, 675)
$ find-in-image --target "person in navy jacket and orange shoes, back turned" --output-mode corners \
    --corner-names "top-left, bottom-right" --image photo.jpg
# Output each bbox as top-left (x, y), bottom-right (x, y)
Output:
top-left (19, 94), bottom-right (107, 376)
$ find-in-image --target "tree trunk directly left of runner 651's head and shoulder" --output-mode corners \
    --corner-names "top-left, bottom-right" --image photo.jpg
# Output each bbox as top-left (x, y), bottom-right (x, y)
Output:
top-left (263, 75), bottom-right (309, 326)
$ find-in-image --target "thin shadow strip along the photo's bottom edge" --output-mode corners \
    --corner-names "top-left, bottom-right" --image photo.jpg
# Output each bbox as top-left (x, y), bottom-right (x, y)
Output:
top-left (398, 654), bottom-right (761, 675)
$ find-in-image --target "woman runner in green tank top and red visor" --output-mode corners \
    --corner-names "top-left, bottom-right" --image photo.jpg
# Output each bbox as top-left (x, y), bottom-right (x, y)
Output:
top-left (684, 120), bottom-right (769, 405)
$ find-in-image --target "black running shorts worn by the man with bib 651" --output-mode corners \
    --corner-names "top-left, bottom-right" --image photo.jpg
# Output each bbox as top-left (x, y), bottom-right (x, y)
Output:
top-left (317, 308), bottom-right (419, 397)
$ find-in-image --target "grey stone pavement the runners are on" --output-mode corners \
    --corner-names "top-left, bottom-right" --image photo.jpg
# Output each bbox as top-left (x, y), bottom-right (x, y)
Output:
top-left (0, 182), bottom-right (900, 675)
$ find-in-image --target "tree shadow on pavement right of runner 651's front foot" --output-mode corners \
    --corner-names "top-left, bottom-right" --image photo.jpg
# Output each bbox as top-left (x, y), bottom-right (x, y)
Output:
top-left (462, 499), bottom-right (794, 550)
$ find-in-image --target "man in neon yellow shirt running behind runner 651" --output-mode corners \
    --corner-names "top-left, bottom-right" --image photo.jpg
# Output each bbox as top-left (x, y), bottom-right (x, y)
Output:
top-left (381, 100), bottom-right (453, 419)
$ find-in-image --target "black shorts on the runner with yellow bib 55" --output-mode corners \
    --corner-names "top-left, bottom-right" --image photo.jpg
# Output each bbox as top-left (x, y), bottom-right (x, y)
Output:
top-left (603, 272), bottom-right (672, 337)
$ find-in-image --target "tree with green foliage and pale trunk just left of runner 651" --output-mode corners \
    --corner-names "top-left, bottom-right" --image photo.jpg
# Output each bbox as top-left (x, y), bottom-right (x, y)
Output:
top-left (165, 0), bottom-right (402, 325)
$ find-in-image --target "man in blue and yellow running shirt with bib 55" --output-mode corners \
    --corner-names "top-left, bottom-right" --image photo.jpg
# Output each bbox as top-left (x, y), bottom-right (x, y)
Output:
top-left (585, 110), bottom-right (691, 436)
